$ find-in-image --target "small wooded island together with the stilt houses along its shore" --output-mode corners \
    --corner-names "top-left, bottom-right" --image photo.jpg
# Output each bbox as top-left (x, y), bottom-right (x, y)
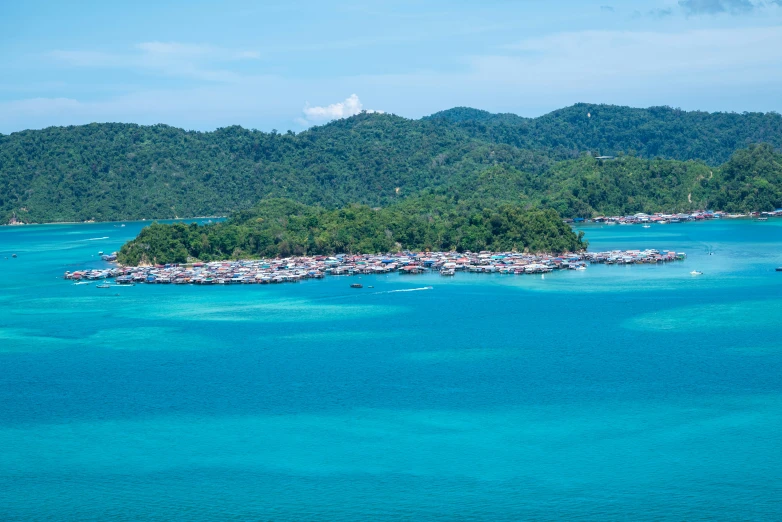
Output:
top-left (65, 198), bottom-right (685, 285)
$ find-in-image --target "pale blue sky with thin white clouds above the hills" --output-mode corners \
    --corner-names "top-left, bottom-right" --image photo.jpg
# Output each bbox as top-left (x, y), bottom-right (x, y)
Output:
top-left (0, 0), bottom-right (782, 133)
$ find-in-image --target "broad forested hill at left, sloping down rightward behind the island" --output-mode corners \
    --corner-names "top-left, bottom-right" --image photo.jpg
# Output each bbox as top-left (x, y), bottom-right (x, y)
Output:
top-left (0, 114), bottom-right (551, 222)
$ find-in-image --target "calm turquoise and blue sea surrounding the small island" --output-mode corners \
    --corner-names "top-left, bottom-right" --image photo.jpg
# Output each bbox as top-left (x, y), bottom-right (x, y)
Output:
top-left (0, 220), bottom-right (782, 521)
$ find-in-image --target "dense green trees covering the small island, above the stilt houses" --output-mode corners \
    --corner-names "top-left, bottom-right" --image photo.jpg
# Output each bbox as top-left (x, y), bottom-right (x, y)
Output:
top-left (119, 196), bottom-right (586, 265)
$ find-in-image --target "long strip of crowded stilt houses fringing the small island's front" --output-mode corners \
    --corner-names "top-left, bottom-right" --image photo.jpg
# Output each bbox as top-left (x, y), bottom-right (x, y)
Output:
top-left (65, 250), bottom-right (685, 285)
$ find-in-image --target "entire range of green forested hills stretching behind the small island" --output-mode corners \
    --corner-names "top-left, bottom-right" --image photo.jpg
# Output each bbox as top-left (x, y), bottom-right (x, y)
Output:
top-left (0, 105), bottom-right (782, 222)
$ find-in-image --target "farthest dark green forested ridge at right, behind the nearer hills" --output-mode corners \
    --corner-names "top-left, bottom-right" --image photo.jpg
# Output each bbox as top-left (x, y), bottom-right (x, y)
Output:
top-left (427, 103), bottom-right (782, 166)
